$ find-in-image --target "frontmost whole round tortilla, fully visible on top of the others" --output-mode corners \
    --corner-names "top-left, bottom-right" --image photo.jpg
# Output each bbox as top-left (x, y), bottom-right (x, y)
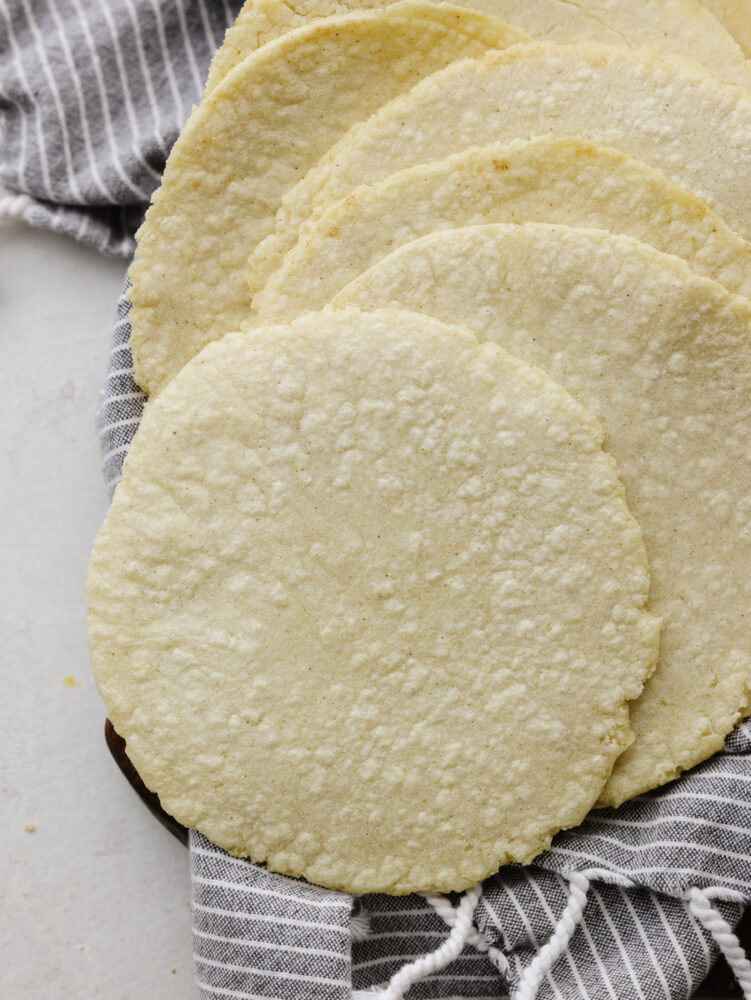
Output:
top-left (88, 310), bottom-right (659, 894)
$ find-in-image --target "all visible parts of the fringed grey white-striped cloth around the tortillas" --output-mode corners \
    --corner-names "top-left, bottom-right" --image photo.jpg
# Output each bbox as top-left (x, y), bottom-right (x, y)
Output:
top-left (5, 0), bottom-right (751, 1000)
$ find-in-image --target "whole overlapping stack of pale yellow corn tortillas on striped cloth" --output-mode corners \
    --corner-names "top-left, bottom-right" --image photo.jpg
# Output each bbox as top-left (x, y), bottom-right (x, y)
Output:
top-left (88, 0), bottom-right (751, 894)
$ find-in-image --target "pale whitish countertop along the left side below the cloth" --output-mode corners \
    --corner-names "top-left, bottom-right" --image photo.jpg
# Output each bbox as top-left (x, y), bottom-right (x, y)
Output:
top-left (0, 224), bottom-right (196, 1000)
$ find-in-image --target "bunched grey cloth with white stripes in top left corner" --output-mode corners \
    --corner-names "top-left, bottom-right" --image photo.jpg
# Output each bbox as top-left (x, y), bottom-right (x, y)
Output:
top-left (0, 0), bottom-right (240, 257)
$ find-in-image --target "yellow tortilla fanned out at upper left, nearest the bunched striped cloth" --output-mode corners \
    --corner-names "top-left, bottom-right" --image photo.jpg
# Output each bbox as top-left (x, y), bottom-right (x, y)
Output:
top-left (129, 0), bottom-right (526, 394)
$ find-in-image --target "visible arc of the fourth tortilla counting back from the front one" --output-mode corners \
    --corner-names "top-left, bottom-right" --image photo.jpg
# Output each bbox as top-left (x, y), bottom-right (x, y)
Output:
top-left (249, 44), bottom-right (751, 294)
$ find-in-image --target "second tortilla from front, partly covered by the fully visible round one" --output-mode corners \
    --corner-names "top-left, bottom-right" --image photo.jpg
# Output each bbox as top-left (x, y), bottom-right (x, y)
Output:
top-left (334, 224), bottom-right (751, 805)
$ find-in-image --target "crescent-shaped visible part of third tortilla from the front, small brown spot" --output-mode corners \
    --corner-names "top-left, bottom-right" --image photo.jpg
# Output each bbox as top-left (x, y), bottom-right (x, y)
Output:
top-left (250, 138), bottom-right (751, 323)
